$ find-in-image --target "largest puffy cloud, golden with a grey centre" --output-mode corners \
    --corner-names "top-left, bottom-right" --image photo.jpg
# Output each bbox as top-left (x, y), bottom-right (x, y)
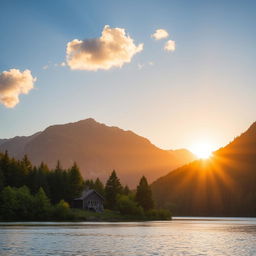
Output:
top-left (66, 25), bottom-right (143, 71)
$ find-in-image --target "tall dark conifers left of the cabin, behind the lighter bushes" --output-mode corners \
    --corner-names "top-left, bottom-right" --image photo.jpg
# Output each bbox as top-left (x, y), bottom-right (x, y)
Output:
top-left (0, 152), bottom-right (84, 204)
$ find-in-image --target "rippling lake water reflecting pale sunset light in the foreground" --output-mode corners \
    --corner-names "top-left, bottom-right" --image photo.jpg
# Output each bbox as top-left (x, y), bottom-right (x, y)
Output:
top-left (0, 218), bottom-right (256, 256)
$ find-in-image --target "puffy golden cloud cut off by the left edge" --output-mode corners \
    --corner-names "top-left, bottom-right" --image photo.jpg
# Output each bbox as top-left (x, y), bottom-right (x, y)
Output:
top-left (0, 69), bottom-right (36, 108)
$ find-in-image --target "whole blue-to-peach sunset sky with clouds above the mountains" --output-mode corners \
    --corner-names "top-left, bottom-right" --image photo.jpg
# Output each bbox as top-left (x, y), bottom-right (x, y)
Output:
top-left (0, 0), bottom-right (256, 149)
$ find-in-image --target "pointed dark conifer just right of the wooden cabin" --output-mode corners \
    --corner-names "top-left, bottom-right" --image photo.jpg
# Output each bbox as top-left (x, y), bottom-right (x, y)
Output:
top-left (105, 170), bottom-right (123, 209)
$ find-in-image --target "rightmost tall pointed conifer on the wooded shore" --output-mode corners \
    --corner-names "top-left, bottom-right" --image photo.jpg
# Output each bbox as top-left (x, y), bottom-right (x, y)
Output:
top-left (135, 176), bottom-right (154, 211)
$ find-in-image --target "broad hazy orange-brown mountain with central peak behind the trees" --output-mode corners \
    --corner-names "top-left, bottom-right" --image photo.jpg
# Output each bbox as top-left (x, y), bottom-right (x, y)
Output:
top-left (0, 118), bottom-right (195, 187)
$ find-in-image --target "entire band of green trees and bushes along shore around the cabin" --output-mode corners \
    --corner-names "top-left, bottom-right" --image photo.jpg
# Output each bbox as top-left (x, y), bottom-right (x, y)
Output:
top-left (0, 152), bottom-right (170, 220)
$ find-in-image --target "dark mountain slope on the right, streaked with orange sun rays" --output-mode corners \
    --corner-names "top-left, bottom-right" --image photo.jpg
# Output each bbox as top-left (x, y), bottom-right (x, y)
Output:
top-left (152, 122), bottom-right (256, 216)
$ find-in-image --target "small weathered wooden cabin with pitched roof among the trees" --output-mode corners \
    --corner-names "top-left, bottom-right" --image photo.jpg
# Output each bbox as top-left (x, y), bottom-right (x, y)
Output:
top-left (73, 189), bottom-right (104, 212)
